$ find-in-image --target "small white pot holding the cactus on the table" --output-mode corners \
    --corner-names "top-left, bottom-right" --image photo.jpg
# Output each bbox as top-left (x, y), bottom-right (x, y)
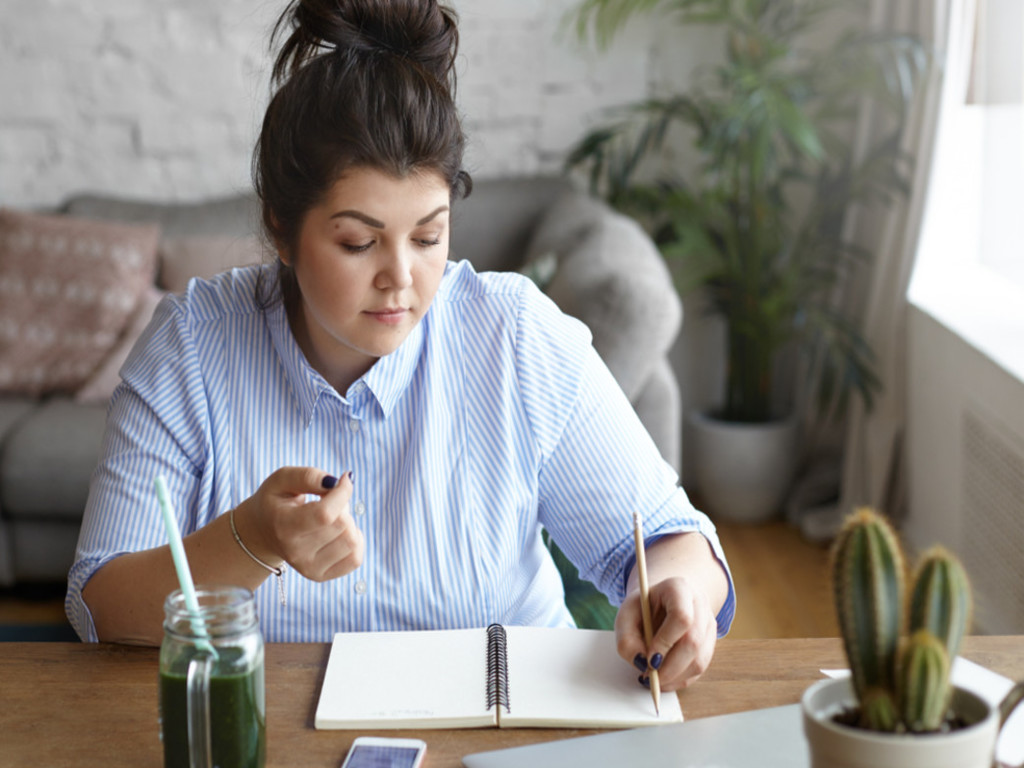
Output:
top-left (801, 678), bottom-right (1019, 768)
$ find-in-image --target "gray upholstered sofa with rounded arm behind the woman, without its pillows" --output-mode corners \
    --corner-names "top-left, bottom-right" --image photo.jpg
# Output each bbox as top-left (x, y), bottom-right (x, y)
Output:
top-left (0, 178), bottom-right (682, 586)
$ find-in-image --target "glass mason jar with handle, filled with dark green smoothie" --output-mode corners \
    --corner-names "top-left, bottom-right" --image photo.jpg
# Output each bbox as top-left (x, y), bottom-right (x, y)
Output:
top-left (160, 587), bottom-right (266, 768)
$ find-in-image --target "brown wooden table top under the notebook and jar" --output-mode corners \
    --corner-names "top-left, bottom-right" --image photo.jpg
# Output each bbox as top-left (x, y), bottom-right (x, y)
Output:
top-left (0, 637), bottom-right (1024, 768)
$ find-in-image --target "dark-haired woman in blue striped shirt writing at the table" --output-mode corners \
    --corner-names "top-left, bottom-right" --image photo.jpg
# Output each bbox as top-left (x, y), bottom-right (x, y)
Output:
top-left (68, 0), bottom-right (733, 690)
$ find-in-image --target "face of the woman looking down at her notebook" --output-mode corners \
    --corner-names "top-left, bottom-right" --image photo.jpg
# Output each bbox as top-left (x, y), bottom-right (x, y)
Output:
top-left (282, 168), bottom-right (451, 392)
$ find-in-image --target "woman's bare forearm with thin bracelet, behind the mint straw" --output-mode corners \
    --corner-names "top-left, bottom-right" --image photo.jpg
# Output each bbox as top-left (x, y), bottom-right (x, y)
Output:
top-left (82, 509), bottom-right (269, 645)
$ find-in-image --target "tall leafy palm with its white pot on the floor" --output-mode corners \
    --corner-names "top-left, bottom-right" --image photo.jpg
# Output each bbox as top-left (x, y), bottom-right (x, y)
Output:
top-left (566, 0), bottom-right (927, 520)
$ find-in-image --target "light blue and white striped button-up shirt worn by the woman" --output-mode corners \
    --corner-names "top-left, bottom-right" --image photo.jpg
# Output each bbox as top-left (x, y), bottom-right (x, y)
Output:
top-left (67, 262), bottom-right (734, 642)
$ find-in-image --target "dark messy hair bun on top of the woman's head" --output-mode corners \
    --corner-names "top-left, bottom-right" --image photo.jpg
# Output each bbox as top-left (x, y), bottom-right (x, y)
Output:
top-left (273, 0), bottom-right (459, 86)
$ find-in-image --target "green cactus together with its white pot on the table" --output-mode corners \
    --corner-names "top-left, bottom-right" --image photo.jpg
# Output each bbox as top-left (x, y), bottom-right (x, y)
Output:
top-left (802, 508), bottom-right (1024, 768)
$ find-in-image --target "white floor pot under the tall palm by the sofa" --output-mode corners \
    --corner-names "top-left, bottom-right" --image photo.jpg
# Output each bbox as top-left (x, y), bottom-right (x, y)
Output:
top-left (686, 411), bottom-right (799, 523)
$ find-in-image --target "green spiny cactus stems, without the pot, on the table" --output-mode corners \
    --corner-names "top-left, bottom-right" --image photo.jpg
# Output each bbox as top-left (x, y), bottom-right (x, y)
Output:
top-left (833, 507), bottom-right (971, 732)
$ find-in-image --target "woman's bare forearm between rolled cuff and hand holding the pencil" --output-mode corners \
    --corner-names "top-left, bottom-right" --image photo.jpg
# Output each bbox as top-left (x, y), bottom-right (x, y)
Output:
top-left (626, 532), bottom-right (729, 614)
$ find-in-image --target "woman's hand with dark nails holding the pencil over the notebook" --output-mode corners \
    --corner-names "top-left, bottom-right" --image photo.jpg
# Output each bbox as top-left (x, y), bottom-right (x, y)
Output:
top-left (615, 577), bottom-right (718, 691)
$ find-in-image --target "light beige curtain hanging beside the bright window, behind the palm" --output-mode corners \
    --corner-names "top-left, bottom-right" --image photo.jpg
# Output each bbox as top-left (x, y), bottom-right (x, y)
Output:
top-left (795, 0), bottom-right (959, 541)
